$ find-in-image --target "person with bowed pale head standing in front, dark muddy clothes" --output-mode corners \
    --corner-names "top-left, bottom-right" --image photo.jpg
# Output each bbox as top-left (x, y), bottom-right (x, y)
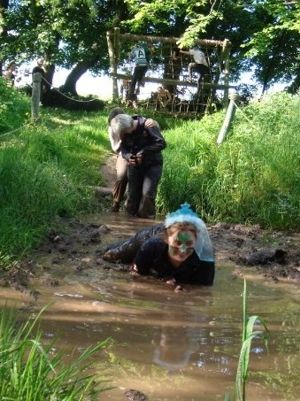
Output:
top-left (110, 114), bottom-right (166, 218)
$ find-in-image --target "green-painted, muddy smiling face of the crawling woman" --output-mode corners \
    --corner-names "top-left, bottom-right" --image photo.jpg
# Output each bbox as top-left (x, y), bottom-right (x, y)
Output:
top-left (167, 229), bottom-right (196, 262)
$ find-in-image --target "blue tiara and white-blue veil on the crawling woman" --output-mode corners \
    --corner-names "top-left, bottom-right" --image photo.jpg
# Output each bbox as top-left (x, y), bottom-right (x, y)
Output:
top-left (165, 202), bottom-right (214, 262)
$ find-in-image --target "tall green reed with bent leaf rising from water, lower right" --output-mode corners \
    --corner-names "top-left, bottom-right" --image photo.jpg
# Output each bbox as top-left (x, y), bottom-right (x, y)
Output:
top-left (235, 280), bottom-right (268, 401)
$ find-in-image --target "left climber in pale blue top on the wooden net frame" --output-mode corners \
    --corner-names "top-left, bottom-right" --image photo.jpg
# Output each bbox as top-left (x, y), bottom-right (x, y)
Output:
top-left (128, 42), bottom-right (150, 101)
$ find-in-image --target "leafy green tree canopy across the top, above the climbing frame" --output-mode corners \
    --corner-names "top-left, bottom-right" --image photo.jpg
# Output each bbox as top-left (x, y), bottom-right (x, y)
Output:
top-left (0, 0), bottom-right (300, 92)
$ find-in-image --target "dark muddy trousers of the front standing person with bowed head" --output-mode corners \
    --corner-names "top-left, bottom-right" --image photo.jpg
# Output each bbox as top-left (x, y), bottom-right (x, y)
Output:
top-left (126, 164), bottom-right (163, 218)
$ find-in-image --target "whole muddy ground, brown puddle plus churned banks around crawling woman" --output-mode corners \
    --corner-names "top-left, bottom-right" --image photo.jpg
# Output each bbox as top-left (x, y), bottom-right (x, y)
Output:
top-left (0, 158), bottom-right (300, 401)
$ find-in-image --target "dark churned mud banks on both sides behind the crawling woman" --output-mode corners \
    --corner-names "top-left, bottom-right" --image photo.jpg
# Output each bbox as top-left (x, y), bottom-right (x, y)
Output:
top-left (0, 157), bottom-right (300, 296)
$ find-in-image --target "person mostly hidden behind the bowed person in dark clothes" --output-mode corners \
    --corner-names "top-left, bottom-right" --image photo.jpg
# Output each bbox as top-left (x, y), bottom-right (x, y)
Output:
top-left (108, 107), bottom-right (159, 213)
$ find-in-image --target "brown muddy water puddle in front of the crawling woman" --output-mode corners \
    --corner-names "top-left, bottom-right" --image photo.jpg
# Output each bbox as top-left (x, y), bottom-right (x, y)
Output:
top-left (0, 216), bottom-right (300, 401)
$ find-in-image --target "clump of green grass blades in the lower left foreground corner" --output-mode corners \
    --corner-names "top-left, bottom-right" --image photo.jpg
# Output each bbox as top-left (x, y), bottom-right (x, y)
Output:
top-left (0, 310), bottom-right (108, 401)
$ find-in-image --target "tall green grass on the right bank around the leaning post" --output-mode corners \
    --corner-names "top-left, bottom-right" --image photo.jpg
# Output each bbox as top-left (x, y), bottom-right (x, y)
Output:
top-left (159, 94), bottom-right (300, 229)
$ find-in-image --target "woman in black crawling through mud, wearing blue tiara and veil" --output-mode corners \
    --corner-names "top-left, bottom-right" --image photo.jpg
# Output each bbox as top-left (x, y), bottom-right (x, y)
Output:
top-left (103, 203), bottom-right (215, 291)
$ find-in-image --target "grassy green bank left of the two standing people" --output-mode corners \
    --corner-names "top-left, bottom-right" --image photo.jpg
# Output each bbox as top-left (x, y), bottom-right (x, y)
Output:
top-left (0, 112), bottom-right (108, 267)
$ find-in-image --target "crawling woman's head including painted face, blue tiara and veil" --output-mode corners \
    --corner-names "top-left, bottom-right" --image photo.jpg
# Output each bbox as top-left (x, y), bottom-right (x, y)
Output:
top-left (164, 203), bottom-right (213, 263)
